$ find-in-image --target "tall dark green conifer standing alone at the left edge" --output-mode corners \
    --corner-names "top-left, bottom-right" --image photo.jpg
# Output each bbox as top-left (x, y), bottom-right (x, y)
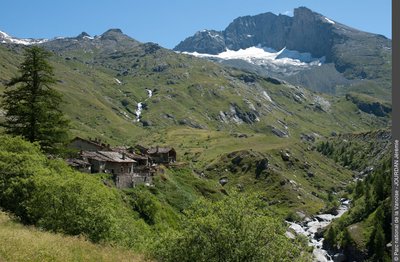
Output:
top-left (1, 46), bottom-right (68, 153)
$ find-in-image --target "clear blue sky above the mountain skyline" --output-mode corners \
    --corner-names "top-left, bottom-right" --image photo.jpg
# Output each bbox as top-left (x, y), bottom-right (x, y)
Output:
top-left (0, 0), bottom-right (391, 48)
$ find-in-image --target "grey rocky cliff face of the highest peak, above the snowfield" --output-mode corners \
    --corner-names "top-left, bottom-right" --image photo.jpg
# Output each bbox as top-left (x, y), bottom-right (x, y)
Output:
top-left (174, 7), bottom-right (391, 81)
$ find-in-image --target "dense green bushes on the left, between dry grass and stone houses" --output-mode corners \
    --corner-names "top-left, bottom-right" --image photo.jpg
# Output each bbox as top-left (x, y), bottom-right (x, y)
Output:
top-left (0, 136), bottom-right (150, 246)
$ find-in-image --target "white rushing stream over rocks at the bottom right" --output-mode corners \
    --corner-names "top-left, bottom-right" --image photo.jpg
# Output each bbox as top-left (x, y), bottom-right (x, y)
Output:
top-left (287, 199), bottom-right (350, 262)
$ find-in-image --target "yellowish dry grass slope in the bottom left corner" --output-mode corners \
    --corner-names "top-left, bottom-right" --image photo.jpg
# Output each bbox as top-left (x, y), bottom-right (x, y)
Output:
top-left (0, 211), bottom-right (145, 262)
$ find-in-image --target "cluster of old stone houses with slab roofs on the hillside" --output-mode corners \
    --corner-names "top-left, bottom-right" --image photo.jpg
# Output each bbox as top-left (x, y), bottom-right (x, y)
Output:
top-left (67, 137), bottom-right (176, 188)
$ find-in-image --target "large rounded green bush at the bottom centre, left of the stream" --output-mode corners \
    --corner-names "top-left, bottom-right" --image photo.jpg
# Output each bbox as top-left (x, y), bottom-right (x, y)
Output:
top-left (152, 193), bottom-right (310, 261)
